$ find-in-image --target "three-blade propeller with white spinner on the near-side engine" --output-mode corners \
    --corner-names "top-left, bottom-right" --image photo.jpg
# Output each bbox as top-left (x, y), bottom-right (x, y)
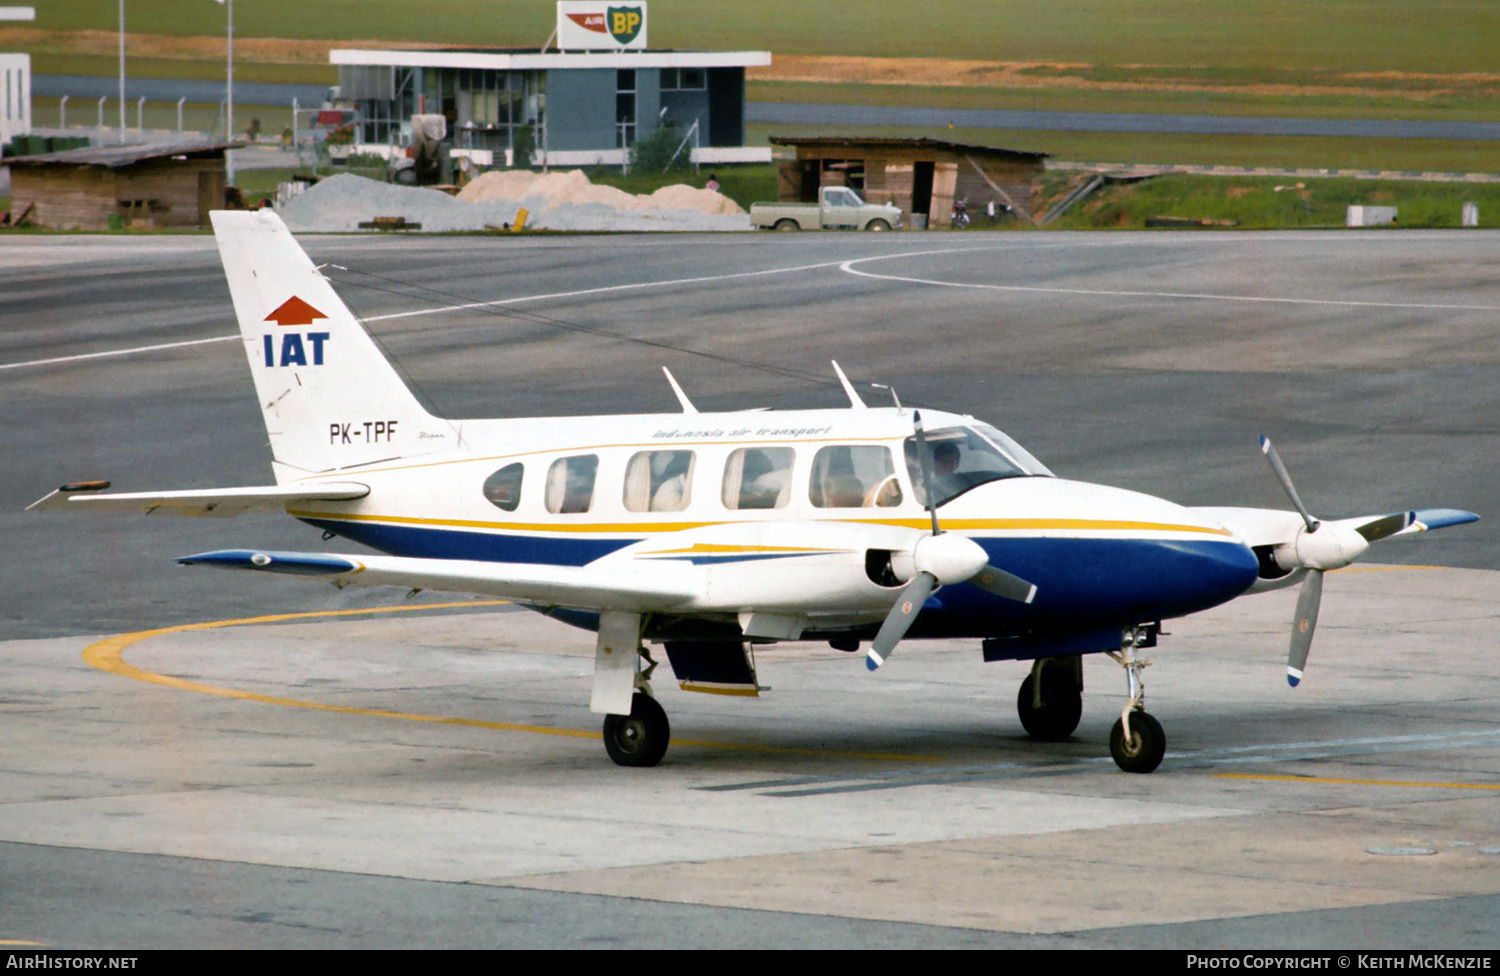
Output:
top-left (864, 411), bottom-right (1037, 672)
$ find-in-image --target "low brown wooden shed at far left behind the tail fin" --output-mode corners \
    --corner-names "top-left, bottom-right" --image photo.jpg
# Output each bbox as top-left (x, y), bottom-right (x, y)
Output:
top-left (6, 142), bottom-right (242, 231)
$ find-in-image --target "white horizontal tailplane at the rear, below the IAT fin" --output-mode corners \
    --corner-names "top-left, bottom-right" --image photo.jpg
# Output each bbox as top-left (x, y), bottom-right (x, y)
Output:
top-left (26, 481), bottom-right (371, 519)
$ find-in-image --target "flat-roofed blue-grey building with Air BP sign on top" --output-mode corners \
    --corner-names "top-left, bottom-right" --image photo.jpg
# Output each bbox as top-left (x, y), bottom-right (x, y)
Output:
top-left (329, 0), bottom-right (771, 166)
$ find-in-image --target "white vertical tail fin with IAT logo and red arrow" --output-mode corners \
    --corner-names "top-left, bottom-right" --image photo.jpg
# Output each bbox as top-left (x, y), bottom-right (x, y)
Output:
top-left (210, 210), bottom-right (458, 481)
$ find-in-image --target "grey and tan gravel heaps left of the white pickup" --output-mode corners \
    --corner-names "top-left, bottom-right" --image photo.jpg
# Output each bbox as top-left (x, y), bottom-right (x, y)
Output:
top-left (281, 172), bottom-right (750, 231)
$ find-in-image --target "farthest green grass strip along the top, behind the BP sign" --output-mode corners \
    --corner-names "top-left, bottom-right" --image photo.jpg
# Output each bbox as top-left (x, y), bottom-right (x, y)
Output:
top-left (36, 0), bottom-right (1500, 72)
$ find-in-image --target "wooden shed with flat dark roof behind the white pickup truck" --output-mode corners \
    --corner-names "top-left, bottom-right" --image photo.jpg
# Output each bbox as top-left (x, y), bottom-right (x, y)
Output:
top-left (771, 136), bottom-right (1047, 226)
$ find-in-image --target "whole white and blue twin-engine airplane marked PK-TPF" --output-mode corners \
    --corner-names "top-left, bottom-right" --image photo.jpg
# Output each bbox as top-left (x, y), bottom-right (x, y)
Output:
top-left (32, 211), bottom-right (1478, 772)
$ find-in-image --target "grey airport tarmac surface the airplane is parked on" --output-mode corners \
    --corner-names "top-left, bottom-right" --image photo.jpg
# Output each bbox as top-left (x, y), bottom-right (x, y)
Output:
top-left (0, 232), bottom-right (1500, 949)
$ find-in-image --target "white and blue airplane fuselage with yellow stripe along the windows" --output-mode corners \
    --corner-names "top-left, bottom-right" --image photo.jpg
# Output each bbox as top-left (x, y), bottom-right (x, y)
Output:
top-left (279, 408), bottom-right (1257, 657)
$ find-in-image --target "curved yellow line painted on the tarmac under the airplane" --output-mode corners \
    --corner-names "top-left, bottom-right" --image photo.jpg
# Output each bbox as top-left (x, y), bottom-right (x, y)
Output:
top-left (83, 600), bottom-right (944, 763)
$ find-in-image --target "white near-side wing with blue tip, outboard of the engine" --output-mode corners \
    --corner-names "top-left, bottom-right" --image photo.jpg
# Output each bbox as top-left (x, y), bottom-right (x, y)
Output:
top-left (177, 549), bottom-right (704, 610)
